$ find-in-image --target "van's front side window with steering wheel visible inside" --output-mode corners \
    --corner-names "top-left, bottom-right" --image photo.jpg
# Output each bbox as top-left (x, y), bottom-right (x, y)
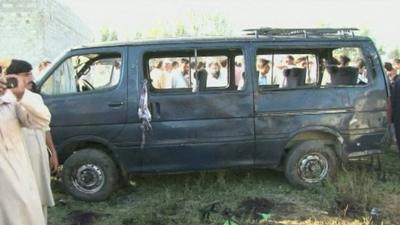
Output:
top-left (41, 53), bottom-right (121, 95)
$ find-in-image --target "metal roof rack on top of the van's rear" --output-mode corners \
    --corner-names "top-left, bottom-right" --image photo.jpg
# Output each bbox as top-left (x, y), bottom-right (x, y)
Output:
top-left (243, 27), bottom-right (359, 38)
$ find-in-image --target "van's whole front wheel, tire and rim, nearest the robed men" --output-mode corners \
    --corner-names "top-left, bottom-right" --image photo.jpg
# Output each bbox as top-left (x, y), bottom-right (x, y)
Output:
top-left (61, 149), bottom-right (119, 201)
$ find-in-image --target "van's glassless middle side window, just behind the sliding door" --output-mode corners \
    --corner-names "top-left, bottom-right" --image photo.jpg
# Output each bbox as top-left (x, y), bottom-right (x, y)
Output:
top-left (255, 52), bottom-right (318, 89)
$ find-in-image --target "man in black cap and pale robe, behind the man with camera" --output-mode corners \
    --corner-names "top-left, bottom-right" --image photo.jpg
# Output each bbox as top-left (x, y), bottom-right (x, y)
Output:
top-left (6, 59), bottom-right (58, 224)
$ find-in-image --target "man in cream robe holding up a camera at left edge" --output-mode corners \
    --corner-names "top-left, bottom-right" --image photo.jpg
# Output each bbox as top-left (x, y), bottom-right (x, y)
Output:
top-left (0, 61), bottom-right (51, 225)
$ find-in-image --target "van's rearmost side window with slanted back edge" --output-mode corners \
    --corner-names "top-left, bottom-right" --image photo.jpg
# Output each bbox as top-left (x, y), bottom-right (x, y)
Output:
top-left (321, 48), bottom-right (371, 86)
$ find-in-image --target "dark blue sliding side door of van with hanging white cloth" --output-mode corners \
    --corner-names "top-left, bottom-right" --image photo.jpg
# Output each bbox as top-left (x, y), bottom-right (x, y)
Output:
top-left (122, 43), bottom-right (254, 172)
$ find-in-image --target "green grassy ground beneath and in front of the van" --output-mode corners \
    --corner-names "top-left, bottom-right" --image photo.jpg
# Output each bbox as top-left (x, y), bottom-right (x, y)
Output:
top-left (49, 150), bottom-right (400, 225)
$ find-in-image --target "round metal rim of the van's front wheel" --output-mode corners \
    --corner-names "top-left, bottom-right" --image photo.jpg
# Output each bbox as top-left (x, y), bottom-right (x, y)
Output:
top-left (71, 164), bottom-right (105, 194)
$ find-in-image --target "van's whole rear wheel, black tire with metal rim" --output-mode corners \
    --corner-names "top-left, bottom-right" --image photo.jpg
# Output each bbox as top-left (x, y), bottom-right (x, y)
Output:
top-left (284, 140), bottom-right (338, 188)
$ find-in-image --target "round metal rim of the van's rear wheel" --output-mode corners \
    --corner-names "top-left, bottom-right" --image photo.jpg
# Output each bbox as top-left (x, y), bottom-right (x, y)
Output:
top-left (298, 153), bottom-right (329, 183)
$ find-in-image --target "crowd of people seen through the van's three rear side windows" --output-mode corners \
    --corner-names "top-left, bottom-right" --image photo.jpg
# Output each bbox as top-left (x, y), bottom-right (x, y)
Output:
top-left (149, 54), bottom-right (368, 90)
